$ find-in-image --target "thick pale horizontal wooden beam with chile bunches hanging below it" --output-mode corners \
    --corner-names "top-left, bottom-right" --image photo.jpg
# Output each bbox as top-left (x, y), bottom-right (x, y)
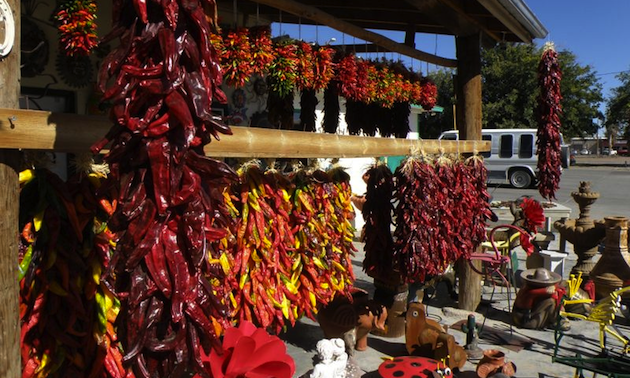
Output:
top-left (0, 109), bottom-right (490, 158)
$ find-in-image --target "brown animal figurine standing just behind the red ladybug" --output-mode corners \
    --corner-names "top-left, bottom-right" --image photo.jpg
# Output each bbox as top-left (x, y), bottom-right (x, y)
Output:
top-left (405, 302), bottom-right (468, 369)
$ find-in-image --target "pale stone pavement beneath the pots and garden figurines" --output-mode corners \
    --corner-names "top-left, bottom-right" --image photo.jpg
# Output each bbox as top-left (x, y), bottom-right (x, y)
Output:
top-left (281, 238), bottom-right (630, 378)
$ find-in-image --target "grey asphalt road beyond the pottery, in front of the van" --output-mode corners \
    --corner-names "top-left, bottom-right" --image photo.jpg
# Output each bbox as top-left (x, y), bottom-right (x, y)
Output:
top-left (488, 161), bottom-right (630, 219)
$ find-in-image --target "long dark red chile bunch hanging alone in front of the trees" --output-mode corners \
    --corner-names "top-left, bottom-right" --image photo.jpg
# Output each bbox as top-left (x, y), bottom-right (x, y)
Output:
top-left (536, 43), bottom-right (562, 200)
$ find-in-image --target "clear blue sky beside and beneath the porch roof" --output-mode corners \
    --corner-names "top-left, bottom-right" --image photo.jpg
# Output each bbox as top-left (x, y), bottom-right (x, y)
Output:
top-left (272, 0), bottom-right (630, 105)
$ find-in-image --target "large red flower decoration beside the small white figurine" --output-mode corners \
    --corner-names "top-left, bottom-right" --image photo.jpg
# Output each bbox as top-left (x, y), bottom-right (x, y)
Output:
top-left (208, 321), bottom-right (295, 378)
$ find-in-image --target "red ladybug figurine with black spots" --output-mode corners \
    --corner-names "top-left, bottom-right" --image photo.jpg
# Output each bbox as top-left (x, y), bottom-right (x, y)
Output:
top-left (378, 356), bottom-right (455, 378)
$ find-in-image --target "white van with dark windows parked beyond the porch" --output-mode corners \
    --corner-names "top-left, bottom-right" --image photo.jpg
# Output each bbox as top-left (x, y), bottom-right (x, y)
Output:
top-left (438, 129), bottom-right (570, 189)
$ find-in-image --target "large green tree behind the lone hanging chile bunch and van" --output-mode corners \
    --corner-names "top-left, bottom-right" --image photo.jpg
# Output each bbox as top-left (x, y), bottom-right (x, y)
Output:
top-left (421, 43), bottom-right (604, 139)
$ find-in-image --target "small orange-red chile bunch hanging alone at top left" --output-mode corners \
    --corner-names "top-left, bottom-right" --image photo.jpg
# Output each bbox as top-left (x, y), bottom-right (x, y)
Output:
top-left (55, 0), bottom-right (98, 56)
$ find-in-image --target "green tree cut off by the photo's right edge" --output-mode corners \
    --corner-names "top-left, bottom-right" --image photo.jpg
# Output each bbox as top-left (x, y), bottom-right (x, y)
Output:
top-left (606, 71), bottom-right (630, 139)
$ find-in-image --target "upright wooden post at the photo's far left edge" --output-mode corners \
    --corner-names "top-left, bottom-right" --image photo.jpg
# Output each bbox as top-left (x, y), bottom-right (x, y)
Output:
top-left (0, 0), bottom-right (21, 378)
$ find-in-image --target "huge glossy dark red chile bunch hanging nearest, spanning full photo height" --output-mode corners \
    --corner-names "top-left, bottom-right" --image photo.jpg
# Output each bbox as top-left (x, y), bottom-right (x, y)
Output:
top-left (92, 0), bottom-right (237, 377)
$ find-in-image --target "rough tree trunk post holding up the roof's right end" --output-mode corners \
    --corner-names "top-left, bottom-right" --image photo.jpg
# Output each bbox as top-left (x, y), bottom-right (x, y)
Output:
top-left (455, 34), bottom-right (481, 311)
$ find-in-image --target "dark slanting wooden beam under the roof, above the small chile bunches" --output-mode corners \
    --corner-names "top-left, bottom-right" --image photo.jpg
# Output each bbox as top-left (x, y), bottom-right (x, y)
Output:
top-left (249, 0), bottom-right (457, 67)
